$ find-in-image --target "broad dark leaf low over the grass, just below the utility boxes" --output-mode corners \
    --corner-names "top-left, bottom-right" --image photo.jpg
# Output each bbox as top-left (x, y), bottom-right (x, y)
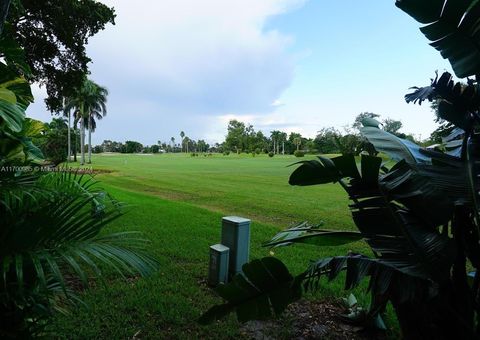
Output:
top-left (199, 257), bottom-right (301, 324)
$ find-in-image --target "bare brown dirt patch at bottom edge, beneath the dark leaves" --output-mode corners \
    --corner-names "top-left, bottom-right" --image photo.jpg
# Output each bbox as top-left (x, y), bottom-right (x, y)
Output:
top-left (240, 300), bottom-right (387, 340)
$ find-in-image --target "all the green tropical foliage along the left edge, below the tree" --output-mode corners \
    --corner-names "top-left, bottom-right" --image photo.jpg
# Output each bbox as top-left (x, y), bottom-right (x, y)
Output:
top-left (0, 1), bottom-right (156, 338)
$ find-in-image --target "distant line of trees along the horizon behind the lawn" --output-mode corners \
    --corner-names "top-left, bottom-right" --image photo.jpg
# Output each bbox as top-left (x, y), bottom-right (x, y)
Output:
top-left (88, 112), bottom-right (430, 155)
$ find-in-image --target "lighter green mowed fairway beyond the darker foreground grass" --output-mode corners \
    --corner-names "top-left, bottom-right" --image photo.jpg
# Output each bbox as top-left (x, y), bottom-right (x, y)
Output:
top-left (89, 154), bottom-right (354, 229)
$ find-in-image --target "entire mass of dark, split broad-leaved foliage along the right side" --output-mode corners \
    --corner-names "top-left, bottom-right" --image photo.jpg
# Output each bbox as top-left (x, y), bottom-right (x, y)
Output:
top-left (201, 0), bottom-right (480, 339)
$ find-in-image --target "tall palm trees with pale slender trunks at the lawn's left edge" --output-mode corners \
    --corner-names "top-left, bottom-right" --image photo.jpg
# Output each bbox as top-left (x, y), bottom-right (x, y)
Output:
top-left (63, 79), bottom-right (108, 165)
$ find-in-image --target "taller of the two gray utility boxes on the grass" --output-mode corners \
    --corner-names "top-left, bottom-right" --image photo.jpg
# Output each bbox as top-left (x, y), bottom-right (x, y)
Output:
top-left (222, 216), bottom-right (250, 275)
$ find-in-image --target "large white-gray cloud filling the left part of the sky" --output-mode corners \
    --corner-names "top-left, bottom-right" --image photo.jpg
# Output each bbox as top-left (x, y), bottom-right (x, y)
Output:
top-left (26, 0), bottom-right (305, 143)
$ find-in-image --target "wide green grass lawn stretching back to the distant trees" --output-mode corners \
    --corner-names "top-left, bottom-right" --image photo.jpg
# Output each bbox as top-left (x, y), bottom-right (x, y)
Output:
top-left (52, 154), bottom-right (394, 339)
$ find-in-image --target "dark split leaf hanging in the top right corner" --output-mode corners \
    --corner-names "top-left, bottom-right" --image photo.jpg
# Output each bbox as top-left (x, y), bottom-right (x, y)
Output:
top-left (395, 0), bottom-right (480, 78)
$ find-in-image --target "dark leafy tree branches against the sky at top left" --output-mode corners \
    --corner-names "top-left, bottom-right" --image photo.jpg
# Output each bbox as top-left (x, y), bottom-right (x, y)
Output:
top-left (5, 0), bottom-right (115, 112)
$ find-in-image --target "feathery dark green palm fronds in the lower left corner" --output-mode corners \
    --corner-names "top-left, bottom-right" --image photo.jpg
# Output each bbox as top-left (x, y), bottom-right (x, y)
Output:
top-left (0, 171), bottom-right (157, 337)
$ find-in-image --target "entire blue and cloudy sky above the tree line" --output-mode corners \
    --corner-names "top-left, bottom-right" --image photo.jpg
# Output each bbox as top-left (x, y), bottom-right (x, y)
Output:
top-left (27, 0), bottom-right (451, 144)
